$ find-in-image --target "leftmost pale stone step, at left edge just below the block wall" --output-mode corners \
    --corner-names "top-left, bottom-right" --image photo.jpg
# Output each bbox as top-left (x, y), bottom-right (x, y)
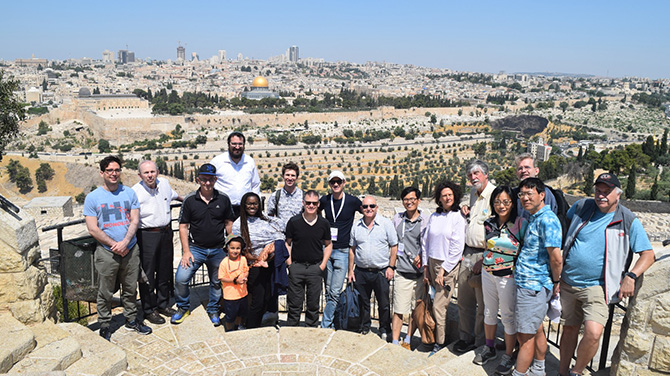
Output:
top-left (0, 313), bottom-right (35, 373)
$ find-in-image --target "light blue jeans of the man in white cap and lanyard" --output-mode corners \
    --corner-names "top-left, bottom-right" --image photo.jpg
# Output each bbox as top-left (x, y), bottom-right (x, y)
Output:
top-left (321, 248), bottom-right (349, 328)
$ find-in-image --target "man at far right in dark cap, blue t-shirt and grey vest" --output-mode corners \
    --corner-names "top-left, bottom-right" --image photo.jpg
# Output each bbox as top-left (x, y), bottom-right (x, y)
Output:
top-left (559, 173), bottom-right (656, 376)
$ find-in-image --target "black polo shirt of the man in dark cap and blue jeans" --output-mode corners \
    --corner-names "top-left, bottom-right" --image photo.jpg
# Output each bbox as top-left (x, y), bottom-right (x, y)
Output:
top-left (179, 189), bottom-right (235, 249)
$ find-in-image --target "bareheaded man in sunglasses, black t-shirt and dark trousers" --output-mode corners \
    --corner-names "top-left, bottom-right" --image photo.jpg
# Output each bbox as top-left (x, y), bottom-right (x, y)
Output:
top-left (286, 190), bottom-right (333, 327)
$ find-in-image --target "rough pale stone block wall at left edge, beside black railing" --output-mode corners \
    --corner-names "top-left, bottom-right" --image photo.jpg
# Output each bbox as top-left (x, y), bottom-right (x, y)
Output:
top-left (0, 209), bottom-right (55, 324)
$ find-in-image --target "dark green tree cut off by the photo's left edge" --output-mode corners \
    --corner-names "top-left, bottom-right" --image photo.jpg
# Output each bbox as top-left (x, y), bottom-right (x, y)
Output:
top-left (0, 70), bottom-right (26, 161)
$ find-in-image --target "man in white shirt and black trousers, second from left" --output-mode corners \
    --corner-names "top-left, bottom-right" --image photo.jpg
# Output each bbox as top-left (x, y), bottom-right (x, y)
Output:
top-left (133, 161), bottom-right (184, 324)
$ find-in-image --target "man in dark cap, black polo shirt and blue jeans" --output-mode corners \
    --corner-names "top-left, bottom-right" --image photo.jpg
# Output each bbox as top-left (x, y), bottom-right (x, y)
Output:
top-left (170, 163), bottom-right (235, 326)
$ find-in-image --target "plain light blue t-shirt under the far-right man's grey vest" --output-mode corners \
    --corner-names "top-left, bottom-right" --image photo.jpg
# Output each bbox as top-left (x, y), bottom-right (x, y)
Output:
top-left (561, 205), bottom-right (652, 287)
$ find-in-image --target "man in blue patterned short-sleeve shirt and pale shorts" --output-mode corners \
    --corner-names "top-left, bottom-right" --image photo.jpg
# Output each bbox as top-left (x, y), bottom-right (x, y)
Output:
top-left (514, 178), bottom-right (563, 376)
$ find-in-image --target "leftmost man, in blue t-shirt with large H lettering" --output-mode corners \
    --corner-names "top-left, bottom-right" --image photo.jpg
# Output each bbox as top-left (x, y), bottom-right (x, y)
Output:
top-left (84, 155), bottom-right (151, 340)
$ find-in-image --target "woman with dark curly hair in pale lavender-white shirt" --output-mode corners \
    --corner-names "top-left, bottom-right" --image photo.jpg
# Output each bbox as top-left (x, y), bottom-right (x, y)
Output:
top-left (421, 180), bottom-right (466, 356)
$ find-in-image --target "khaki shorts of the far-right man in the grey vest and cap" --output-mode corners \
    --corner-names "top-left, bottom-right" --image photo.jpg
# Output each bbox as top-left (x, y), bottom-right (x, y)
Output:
top-left (561, 281), bottom-right (609, 326)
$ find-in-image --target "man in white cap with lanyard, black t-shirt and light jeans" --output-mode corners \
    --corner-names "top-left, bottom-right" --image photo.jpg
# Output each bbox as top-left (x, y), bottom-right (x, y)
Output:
top-left (319, 170), bottom-right (363, 328)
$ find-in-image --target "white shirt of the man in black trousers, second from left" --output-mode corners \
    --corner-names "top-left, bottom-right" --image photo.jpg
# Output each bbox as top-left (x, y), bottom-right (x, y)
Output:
top-left (133, 179), bottom-right (179, 228)
